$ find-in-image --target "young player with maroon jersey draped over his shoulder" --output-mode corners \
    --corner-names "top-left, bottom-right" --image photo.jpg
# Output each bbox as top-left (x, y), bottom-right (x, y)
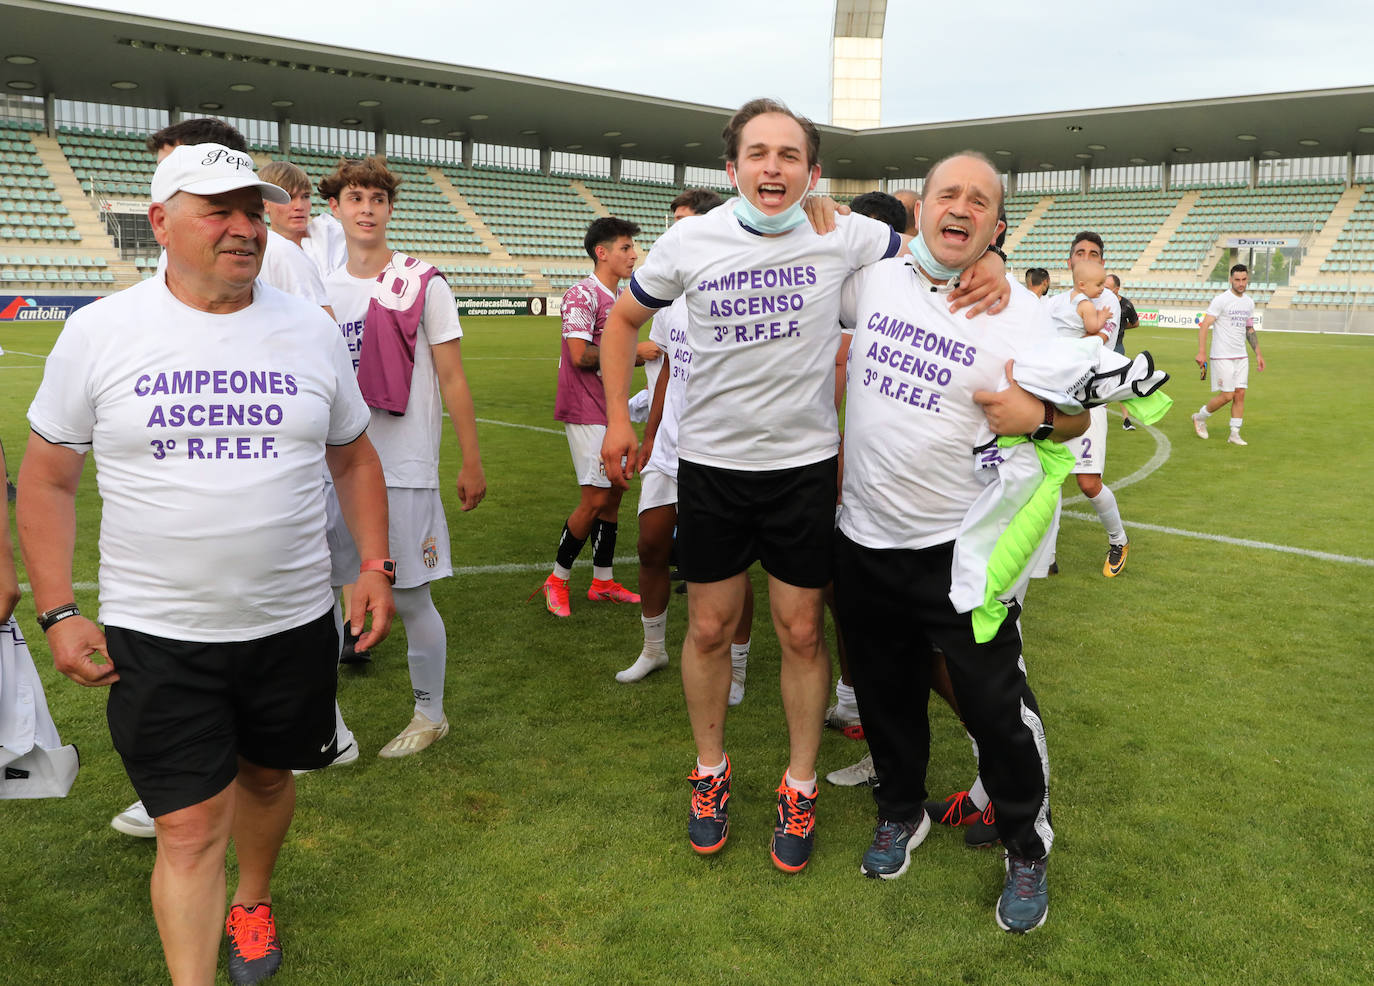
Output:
top-left (320, 158), bottom-right (486, 758)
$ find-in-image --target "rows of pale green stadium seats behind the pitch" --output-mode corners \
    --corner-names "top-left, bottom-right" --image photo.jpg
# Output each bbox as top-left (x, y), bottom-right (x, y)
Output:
top-left (0, 121), bottom-right (1374, 308)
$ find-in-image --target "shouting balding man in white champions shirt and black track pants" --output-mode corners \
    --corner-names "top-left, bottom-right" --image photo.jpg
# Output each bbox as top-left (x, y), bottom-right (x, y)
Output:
top-left (835, 152), bottom-right (1087, 932)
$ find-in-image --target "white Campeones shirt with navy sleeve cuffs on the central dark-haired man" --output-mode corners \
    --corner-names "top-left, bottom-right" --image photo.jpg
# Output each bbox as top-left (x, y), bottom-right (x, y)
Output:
top-left (631, 206), bottom-right (901, 471)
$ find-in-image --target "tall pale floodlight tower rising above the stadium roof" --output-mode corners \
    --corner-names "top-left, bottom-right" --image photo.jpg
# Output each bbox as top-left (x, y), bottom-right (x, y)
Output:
top-left (830, 0), bottom-right (888, 194)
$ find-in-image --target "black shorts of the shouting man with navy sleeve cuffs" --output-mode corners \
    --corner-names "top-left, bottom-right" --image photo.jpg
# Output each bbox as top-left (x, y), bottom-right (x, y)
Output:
top-left (677, 459), bottom-right (838, 589)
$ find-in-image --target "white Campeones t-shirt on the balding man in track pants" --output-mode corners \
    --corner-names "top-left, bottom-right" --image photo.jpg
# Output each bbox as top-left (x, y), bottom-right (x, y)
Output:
top-left (840, 257), bottom-right (1054, 548)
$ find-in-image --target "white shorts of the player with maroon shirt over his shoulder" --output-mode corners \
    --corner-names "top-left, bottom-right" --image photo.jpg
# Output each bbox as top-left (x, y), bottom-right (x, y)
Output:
top-left (324, 483), bottom-right (453, 589)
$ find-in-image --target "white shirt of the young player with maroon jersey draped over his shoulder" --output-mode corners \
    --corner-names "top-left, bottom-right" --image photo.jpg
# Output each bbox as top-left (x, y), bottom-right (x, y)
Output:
top-left (324, 268), bottom-right (463, 489)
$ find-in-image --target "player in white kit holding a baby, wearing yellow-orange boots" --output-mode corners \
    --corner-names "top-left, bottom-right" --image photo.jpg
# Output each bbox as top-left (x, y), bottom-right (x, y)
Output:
top-left (1046, 229), bottom-right (1131, 578)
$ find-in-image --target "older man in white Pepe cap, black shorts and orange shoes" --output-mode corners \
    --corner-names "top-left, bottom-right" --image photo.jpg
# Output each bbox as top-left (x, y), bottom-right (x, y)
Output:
top-left (19, 144), bottom-right (394, 985)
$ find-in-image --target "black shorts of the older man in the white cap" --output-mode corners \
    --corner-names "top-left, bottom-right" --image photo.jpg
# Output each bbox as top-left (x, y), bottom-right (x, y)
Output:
top-left (104, 610), bottom-right (338, 817)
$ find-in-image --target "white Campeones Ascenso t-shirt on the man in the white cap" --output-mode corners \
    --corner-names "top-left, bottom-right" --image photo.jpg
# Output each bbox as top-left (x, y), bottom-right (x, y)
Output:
top-left (29, 277), bottom-right (368, 641)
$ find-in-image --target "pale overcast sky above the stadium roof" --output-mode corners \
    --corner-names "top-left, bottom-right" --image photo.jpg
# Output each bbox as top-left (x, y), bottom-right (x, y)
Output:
top-left (69, 0), bottom-right (1374, 126)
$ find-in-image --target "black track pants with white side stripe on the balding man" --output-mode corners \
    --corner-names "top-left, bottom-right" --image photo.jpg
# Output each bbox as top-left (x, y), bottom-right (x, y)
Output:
top-left (835, 533), bottom-right (1054, 858)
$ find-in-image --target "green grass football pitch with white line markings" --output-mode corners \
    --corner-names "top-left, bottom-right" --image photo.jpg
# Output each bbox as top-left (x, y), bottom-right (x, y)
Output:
top-left (0, 319), bottom-right (1374, 986)
